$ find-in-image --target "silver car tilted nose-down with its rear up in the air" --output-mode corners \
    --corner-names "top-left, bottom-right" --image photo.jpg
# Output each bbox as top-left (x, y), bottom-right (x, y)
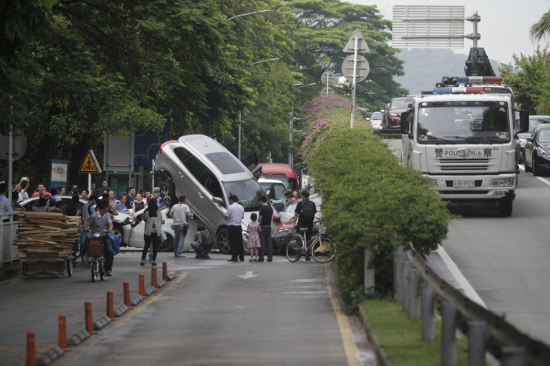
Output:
top-left (153, 135), bottom-right (276, 254)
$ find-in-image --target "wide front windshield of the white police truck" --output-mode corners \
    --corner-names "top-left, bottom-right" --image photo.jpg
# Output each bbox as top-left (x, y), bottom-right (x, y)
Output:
top-left (416, 102), bottom-right (511, 144)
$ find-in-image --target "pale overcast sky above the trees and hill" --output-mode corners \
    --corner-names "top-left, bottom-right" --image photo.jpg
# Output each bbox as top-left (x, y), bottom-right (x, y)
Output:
top-left (348, 0), bottom-right (550, 63)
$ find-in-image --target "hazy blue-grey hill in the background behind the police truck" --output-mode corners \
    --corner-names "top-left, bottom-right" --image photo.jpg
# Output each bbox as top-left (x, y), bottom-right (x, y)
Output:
top-left (395, 49), bottom-right (499, 94)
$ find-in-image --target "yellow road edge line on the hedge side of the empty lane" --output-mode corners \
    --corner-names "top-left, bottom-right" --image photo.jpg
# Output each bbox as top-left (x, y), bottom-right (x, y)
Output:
top-left (324, 263), bottom-right (361, 366)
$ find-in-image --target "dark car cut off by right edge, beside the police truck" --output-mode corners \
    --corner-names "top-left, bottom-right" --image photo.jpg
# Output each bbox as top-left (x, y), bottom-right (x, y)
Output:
top-left (525, 124), bottom-right (550, 176)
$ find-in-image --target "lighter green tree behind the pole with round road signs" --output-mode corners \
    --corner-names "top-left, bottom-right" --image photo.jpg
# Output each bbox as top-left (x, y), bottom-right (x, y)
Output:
top-left (289, 0), bottom-right (407, 110)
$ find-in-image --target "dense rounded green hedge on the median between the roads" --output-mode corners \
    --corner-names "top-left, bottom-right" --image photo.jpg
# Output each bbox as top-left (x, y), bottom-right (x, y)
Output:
top-left (307, 127), bottom-right (451, 306)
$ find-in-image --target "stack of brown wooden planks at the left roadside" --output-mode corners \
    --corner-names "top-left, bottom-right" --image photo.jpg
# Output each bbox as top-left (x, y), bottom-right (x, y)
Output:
top-left (13, 211), bottom-right (82, 259)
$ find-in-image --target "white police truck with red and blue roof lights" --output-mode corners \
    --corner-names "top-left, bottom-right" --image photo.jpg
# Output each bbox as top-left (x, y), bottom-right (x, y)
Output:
top-left (401, 76), bottom-right (528, 216)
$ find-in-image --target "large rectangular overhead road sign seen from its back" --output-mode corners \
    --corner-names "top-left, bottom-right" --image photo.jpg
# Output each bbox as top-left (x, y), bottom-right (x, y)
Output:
top-left (392, 5), bottom-right (466, 49)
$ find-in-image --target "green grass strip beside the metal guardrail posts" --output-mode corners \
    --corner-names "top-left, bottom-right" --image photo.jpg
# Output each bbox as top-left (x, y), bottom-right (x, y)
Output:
top-left (361, 300), bottom-right (474, 366)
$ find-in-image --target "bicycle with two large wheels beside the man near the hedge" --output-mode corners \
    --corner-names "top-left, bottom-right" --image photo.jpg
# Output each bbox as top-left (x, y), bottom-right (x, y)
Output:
top-left (286, 228), bottom-right (335, 263)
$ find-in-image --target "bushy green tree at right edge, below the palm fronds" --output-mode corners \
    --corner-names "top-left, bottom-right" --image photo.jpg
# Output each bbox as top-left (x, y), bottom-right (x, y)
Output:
top-left (499, 47), bottom-right (550, 114)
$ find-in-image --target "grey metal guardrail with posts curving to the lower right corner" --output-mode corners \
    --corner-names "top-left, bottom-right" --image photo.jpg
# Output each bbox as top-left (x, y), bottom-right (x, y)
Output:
top-left (393, 247), bottom-right (550, 366)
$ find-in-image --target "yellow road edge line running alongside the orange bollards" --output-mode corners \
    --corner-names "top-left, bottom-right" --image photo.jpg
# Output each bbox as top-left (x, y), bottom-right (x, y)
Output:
top-left (56, 272), bottom-right (188, 365)
